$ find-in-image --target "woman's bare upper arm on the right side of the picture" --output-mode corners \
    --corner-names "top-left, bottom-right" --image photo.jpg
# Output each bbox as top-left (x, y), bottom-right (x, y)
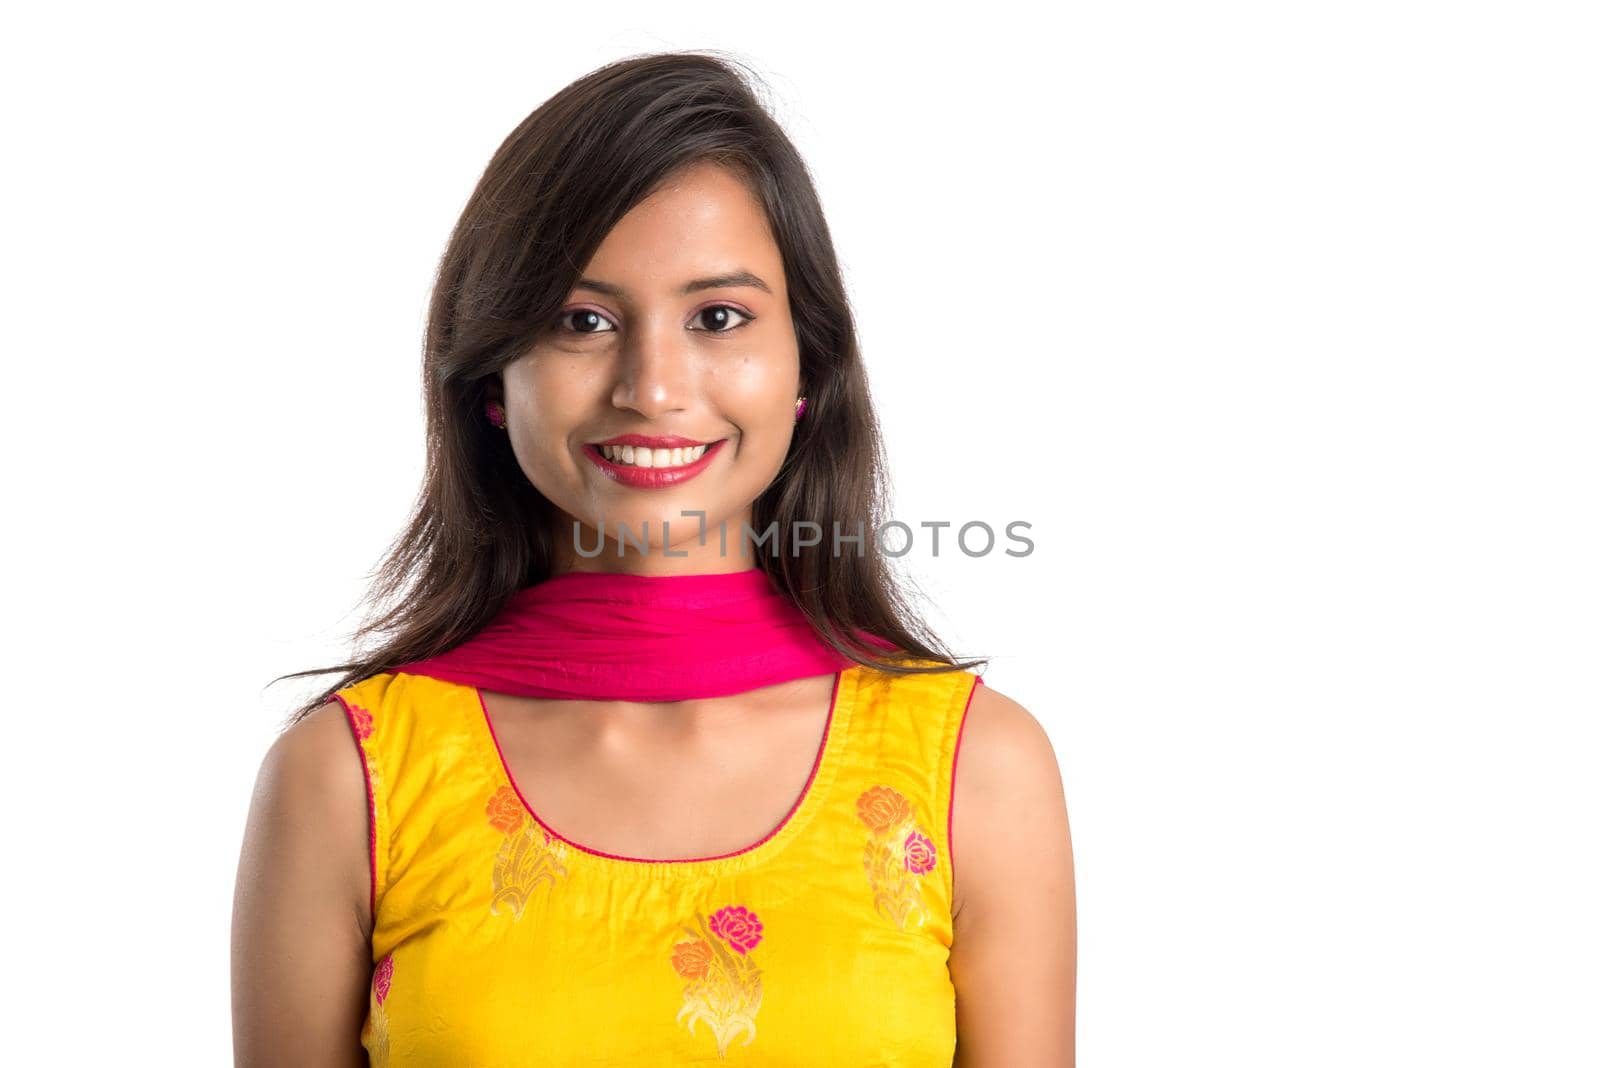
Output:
top-left (950, 684), bottom-right (1078, 1068)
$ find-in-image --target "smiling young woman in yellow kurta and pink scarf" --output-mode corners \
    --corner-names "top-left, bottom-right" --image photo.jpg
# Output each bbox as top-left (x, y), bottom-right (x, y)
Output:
top-left (234, 53), bottom-right (1077, 1068)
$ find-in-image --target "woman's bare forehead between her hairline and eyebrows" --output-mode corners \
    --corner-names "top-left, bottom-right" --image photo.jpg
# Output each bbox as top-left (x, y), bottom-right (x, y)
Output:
top-left (582, 163), bottom-right (782, 291)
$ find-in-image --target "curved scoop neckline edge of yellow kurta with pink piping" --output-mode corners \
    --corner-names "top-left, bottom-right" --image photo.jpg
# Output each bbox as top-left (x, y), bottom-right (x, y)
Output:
top-left (469, 665), bottom-right (861, 873)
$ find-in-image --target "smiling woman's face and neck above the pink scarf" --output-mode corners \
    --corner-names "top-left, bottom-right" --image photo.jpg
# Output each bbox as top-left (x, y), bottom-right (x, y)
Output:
top-left (501, 163), bottom-right (800, 572)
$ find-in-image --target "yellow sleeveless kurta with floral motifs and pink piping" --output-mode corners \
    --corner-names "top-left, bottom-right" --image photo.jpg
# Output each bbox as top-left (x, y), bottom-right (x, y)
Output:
top-left (338, 667), bottom-right (979, 1068)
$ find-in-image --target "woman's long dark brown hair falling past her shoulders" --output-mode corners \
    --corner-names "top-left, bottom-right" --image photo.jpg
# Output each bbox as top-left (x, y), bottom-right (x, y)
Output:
top-left (274, 51), bottom-right (986, 735)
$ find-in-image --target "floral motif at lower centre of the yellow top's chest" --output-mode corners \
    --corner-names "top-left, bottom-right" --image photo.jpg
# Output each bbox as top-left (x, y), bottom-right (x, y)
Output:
top-left (672, 905), bottom-right (762, 1057)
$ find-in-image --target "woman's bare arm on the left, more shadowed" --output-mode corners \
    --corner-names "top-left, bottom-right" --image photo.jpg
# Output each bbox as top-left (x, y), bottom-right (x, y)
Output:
top-left (232, 702), bottom-right (373, 1068)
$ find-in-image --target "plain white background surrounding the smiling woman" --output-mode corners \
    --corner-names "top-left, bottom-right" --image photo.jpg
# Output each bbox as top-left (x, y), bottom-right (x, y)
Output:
top-left (0, 0), bottom-right (1600, 1068)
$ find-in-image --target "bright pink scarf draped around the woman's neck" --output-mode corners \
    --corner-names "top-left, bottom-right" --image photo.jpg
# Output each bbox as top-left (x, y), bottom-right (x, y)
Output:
top-left (394, 568), bottom-right (893, 702)
